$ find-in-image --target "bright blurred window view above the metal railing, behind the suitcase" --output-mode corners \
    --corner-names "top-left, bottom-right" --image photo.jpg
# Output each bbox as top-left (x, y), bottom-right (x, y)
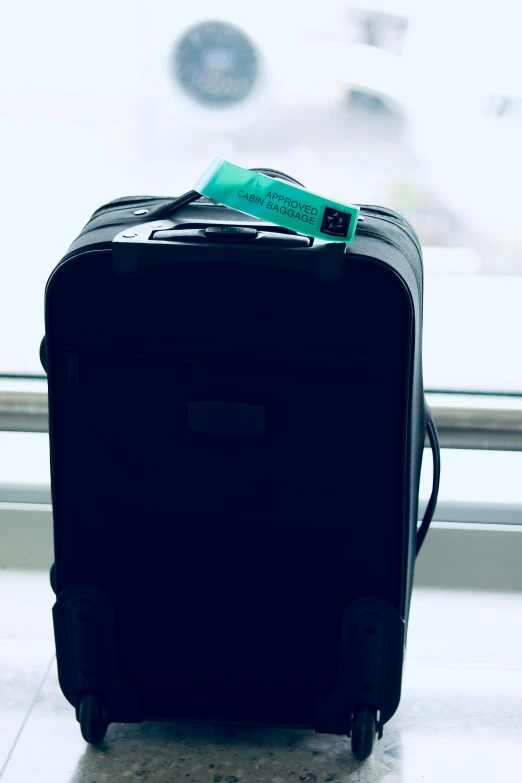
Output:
top-left (0, 0), bottom-right (522, 391)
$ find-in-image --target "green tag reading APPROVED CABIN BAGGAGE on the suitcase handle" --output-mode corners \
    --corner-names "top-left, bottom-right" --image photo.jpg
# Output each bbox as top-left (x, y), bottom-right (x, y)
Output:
top-left (194, 155), bottom-right (359, 243)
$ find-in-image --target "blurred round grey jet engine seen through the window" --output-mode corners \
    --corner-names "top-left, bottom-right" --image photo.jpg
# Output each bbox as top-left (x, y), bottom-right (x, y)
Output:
top-left (172, 22), bottom-right (259, 108)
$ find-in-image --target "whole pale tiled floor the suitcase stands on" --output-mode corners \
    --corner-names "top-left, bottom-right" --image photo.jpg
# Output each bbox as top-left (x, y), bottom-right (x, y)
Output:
top-left (0, 571), bottom-right (522, 783)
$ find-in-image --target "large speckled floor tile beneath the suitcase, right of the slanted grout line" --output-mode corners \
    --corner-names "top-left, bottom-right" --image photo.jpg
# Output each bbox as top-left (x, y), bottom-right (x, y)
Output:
top-left (2, 664), bottom-right (522, 783)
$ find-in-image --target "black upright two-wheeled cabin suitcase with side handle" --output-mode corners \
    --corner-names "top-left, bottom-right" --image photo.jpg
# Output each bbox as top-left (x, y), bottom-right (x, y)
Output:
top-left (42, 170), bottom-right (439, 758)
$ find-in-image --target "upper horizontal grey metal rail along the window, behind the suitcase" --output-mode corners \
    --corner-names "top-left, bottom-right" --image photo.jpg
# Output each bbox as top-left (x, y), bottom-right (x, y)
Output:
top-left (0, 390), bottom-right (522, 451)
